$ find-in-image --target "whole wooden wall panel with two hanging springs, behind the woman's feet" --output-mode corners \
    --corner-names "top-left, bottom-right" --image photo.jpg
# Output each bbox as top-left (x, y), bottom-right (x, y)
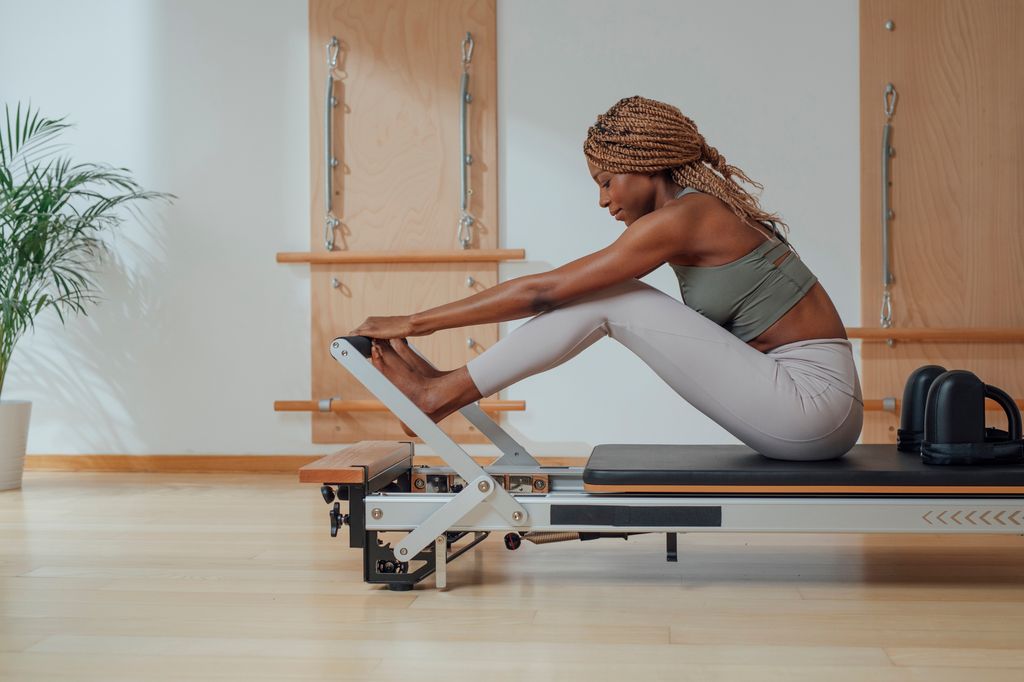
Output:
top-left (309, 0), bottom-right (500, 442)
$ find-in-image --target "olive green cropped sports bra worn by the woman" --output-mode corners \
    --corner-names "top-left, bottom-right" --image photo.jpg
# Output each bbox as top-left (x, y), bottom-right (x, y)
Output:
top-left (669, 187), bottom-right (818, 341)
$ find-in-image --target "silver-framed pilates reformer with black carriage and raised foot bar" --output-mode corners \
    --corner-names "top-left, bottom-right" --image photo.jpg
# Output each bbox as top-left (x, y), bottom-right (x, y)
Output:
top-left (299, 337), bottom-right (1024, 590)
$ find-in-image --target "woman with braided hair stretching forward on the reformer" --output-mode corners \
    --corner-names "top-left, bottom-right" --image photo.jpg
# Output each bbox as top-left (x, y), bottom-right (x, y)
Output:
top-left (349, 96), bottom-right (863, 460)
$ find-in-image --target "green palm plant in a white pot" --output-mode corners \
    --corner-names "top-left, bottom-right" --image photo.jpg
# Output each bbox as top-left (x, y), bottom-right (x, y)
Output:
top-left (0, 103), bottom-right (175, 491)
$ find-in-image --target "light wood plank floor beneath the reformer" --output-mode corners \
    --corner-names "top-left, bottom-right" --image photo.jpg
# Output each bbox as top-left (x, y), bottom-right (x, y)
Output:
top-left (0, 472), bottom-right (1024, 682)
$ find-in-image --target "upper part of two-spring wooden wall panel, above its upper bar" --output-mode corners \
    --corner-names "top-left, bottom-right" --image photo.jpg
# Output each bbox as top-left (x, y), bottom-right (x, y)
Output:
top-left (309, 0), bottom-right (499, 251)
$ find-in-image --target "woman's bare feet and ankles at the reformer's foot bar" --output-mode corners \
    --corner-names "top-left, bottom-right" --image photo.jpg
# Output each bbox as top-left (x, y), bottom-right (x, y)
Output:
top-left (371, 341), bottom-right (481, 435)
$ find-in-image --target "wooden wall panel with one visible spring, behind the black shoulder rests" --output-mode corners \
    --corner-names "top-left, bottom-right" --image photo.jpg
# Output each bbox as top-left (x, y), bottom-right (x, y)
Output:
top-left (860, 0), bottom-right (1024, 442)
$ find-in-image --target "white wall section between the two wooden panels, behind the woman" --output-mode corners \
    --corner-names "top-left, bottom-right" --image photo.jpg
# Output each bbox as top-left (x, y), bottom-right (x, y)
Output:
top-left (498, 0), bottom-right (860, 454)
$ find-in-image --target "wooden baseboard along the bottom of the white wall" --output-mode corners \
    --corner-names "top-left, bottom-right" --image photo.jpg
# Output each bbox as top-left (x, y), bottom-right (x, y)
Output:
top-left (25, 455), bottom-right (587, 473)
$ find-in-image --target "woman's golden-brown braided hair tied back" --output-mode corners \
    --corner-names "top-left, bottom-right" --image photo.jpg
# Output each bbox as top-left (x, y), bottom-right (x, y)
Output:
top-left (583, 95), bottom-right (790, 240)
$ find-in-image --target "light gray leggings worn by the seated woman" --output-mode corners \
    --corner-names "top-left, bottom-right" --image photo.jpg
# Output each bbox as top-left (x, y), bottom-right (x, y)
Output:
top-left (466, 280), bottom-right (864, 461)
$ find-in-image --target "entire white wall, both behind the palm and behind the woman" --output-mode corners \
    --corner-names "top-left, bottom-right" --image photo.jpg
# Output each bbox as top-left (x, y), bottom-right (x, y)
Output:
top-left (0, 0), bottom-right (860, 455)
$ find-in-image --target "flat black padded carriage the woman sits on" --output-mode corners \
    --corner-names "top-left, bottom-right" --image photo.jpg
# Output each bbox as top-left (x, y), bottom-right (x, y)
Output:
top-left (583, 444), bottom-right (1024, 498)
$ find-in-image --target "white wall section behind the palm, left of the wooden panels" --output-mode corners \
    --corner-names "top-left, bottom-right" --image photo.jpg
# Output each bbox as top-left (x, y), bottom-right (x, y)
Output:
top-left (0, 0), bottom-right (316, 454)
